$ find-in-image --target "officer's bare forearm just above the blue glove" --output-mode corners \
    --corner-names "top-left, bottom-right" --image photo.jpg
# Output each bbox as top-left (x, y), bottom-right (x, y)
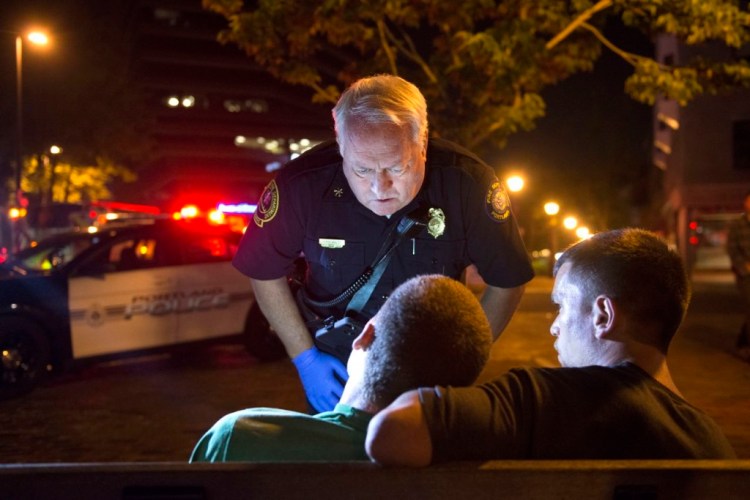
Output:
top-left (250, 277), bottom-right (313, 358)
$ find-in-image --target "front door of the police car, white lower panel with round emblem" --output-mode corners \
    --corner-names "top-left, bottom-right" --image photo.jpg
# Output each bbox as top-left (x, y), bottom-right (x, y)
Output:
top-left (69, 231), bottom-right (184, 358)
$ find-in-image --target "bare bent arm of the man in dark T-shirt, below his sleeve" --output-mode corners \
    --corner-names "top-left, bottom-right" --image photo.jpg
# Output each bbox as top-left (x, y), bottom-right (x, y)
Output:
top-left (365, 391), bottom-right (432, 467)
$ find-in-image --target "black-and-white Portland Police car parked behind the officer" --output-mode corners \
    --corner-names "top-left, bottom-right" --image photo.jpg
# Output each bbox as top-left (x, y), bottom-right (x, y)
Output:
top-left (0, 220), bottom-right (279, 399)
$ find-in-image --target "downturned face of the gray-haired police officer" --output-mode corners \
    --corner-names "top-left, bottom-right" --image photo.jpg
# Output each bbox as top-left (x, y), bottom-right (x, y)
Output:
top-left (343, 125), bottom-right (425, 215)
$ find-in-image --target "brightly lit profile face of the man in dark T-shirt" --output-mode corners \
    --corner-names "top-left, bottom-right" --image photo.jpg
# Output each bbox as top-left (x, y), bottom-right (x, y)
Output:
top-left (550, 262), bottom-right (599, 367)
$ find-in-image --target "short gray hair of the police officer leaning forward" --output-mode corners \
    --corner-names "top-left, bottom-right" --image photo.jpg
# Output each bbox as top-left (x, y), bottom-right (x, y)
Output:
top-left (332, 75), bottom-right (428, 154)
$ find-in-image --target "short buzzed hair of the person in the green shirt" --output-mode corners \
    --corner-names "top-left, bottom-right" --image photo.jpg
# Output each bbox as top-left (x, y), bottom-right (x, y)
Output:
top-left (364, 275), bottom-right (492, 407)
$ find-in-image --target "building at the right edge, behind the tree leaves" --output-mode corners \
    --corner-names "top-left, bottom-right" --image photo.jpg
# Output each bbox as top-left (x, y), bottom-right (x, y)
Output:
top-left (653, 35), bottom-right (750, 270)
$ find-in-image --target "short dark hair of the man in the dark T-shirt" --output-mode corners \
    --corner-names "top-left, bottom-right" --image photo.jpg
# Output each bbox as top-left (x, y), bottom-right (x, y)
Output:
top-left (555, 228), bottom-right (690, 354)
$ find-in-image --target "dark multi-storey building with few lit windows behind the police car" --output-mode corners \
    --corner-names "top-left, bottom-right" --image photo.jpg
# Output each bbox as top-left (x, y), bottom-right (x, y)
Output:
top-left (119, 0), bottom-right (333, 211)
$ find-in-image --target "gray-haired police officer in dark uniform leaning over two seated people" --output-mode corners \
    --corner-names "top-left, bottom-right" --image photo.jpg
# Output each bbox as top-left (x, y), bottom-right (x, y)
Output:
top-left (234, 75), bottom-right (533, 411)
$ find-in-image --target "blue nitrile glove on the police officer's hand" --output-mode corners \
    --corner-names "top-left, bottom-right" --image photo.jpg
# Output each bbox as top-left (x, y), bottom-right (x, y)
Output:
top-left (292, 347), bottom-right (349, 412)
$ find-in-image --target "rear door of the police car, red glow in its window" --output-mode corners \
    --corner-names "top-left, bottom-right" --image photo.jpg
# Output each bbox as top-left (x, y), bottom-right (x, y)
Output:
top-left (173, 232), bottom-right (253, 342)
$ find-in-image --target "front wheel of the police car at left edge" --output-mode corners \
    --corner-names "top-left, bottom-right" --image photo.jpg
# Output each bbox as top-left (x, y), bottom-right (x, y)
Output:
top-left (0, 316), bottom-right (50, 400)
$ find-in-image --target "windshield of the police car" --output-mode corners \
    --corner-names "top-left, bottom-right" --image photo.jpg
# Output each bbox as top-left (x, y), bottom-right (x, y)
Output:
top-left (13, 234), bottom-right (95, 271)
